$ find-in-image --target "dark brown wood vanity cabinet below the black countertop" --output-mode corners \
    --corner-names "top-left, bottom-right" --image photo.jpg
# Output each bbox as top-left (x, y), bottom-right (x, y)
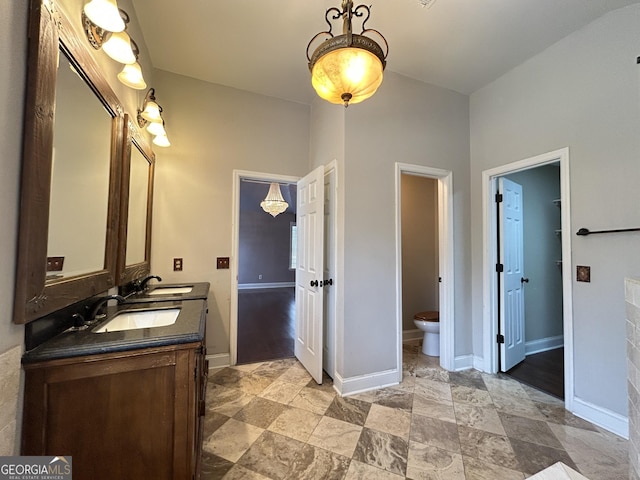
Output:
top-left (22, 342), bottom-right (207, 480)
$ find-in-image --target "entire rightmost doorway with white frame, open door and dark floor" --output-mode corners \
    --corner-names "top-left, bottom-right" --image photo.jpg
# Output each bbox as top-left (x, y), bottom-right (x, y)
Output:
top-left (483, 149), bottom-right (573, 409)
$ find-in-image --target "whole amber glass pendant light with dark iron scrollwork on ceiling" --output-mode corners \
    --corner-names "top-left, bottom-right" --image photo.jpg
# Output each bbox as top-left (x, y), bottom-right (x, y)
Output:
top-left (307, 0), bottom-right (389, 107)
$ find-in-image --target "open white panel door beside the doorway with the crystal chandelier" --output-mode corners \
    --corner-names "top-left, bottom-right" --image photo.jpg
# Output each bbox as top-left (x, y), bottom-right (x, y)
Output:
top-left (294, 166), bottom-right (324, 384)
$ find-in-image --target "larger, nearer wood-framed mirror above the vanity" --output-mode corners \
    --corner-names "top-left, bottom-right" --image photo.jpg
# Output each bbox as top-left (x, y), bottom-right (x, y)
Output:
top-left (13, 0), bottom-right (125, 323)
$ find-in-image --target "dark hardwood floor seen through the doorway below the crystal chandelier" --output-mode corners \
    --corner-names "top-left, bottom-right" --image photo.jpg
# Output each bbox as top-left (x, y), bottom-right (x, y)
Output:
top-left (238, 287), bottom-right (295, 364)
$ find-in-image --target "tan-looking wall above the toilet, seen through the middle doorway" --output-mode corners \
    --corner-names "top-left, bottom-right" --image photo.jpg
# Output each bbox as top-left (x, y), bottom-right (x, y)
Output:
top-left (400, 174), bottom-right (439, 330)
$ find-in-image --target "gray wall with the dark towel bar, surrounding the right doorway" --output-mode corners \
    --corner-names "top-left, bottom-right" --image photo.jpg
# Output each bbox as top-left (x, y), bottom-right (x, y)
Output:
top-left (471, 5), bottom-right (640, 416)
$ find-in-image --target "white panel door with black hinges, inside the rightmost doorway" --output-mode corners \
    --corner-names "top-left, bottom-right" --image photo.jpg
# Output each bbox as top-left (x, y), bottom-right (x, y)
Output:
top-left (498, 178), bottom-right (525, 372)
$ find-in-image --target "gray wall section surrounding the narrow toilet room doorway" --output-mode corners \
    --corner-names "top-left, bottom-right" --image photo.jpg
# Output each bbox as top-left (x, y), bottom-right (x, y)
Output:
top-left (339, 72), bottom-right (472, 378)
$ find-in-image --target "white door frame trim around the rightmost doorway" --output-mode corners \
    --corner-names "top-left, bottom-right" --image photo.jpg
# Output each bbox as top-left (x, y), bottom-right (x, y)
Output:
top-left (482, 147), bottom-right (574, 410)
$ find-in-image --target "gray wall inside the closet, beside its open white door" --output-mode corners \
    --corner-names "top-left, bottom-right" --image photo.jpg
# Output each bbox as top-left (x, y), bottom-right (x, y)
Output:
top-left (506, 165), bottom-right (562, 342)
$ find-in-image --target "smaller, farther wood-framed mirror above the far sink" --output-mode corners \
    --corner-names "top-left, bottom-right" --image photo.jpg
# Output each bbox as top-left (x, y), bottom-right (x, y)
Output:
top-left (118, 119), bottom-right (155, 285)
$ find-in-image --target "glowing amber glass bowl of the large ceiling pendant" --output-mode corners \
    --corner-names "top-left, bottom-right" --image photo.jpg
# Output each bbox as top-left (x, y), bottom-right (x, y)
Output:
top-left (311, 47), bottom-right (384, 105)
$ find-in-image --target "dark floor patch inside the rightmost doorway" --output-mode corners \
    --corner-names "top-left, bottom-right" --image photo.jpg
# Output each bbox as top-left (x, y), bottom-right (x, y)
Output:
top-left (507, 348), bottom-right (564, 399)
